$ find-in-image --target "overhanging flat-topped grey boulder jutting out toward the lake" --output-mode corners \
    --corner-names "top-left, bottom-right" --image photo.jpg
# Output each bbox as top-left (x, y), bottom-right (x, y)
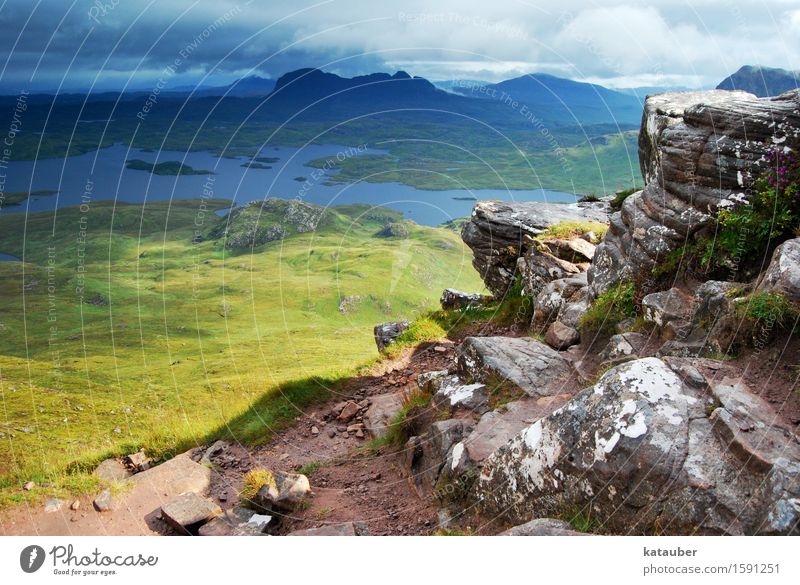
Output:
top-left (461, 201), bottom-right (609, 298)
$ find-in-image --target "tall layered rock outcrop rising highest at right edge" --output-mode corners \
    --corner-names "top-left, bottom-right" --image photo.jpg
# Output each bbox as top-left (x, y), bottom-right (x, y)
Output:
top-left (589, 90), bottom-right (800, 296)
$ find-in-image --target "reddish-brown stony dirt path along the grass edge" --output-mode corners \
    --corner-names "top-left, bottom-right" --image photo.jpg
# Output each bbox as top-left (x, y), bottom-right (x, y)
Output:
top-left (0, 343), bottom-right (454, 536)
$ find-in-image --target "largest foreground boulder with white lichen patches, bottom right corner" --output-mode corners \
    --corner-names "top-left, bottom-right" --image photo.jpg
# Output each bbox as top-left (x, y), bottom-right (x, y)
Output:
top-left (472, 358), bottom-right (800, 534)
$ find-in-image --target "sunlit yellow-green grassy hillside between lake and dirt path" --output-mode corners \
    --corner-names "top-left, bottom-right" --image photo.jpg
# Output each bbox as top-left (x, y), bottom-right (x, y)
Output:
top-left (0, 200), bottom-right (482, 500)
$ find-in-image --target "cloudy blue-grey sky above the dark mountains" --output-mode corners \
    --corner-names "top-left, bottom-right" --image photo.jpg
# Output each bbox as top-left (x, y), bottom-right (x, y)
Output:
top-left (0, 0), bottom-right (800, 93)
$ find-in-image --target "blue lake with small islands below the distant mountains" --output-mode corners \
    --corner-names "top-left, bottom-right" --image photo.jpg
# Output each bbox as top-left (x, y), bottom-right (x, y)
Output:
top-left (0, 144), bottom-right (575, 225)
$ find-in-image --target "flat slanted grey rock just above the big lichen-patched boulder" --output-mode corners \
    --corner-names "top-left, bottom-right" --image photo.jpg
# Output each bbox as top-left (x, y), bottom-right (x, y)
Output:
top-left (457, 337), bottom-right (572, 396)
